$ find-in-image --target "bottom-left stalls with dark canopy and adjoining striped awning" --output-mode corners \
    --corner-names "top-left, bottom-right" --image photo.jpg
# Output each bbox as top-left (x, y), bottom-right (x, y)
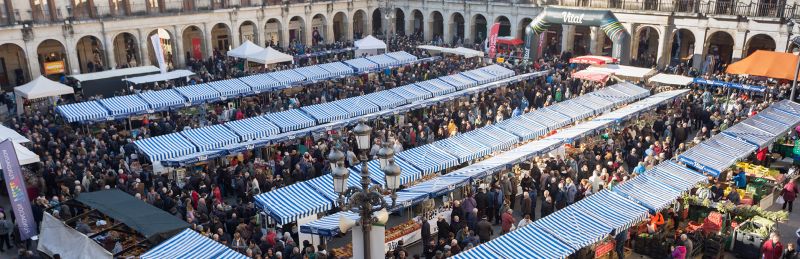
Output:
top-left (37, 189), bottom-right (246, 259)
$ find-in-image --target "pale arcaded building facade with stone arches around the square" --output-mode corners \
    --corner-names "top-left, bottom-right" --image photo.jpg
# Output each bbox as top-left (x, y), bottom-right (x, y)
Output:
top-left (0, 0), bottom-right (800, 89)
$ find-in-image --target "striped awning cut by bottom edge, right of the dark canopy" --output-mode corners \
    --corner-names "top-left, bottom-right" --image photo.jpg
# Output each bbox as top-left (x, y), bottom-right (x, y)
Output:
top-left (140, 228), bottom-right (247, 259)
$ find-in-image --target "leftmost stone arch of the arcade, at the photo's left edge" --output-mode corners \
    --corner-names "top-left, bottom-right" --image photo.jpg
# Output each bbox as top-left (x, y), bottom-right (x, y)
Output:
top-left (0, 43), bottom-right (30, 87)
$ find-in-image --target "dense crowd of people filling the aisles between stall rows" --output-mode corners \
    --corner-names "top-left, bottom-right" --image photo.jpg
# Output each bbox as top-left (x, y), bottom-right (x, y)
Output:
top-left (0, 33), bottom-right (788, 259)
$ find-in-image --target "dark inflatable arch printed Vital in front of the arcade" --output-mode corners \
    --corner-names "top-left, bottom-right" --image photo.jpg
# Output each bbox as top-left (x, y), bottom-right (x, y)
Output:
top-left (525, 7), bottom-right (631, 64)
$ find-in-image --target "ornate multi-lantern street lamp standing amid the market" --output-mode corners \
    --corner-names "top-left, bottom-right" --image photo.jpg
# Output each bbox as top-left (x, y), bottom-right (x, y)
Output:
top-left (328, 120), bottom-right (401, 258)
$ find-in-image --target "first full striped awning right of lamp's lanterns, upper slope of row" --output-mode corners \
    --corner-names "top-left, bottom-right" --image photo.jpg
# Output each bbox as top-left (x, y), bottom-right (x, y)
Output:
top-left (395, 145), bottom-right (459, 174)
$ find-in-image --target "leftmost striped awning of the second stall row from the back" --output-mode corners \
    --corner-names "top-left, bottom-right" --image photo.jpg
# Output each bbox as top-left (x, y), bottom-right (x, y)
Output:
top-left (133, 133), bottom-right (197, 162)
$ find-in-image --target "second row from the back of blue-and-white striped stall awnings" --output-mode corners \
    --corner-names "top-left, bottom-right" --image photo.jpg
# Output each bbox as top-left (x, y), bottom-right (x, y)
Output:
top-left (134, 65), bottom-right (520, 167)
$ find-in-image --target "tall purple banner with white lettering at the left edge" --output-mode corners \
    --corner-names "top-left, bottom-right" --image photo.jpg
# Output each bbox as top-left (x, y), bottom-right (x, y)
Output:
top-left (0, 139), bottom-right (37, 240)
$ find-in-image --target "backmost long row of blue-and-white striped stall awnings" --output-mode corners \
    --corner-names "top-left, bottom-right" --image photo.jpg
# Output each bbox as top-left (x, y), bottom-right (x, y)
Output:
top-left (56, 51), bottom-right (436, 123)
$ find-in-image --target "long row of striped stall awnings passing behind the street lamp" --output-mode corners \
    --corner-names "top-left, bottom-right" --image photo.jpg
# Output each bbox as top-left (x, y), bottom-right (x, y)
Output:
top-left (248, 84), bottom-right (666, 256)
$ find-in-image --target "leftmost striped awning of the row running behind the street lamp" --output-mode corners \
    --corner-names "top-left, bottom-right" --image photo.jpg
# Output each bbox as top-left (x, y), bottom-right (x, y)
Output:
top-left (254, 182), bottom-right (333, 225)
